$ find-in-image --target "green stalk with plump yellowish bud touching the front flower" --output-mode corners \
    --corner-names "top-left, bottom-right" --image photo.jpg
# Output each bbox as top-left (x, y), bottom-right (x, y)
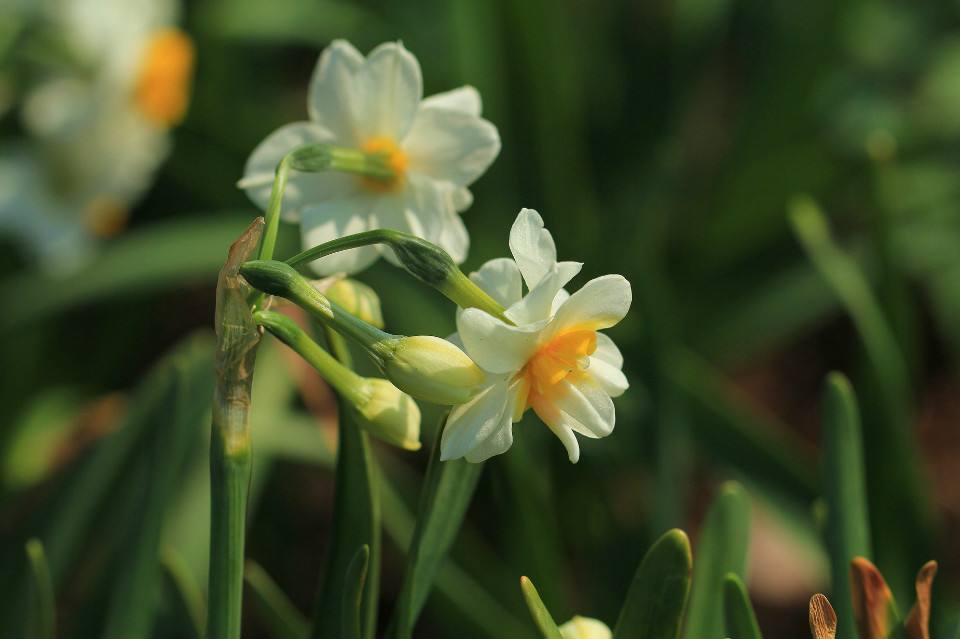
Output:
top-left (240, 260), bottom-right (485, 405)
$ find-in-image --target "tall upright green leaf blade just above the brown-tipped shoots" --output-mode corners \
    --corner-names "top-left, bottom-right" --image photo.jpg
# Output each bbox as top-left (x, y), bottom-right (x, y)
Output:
top-left (821, 373), bottom-right (872, 637)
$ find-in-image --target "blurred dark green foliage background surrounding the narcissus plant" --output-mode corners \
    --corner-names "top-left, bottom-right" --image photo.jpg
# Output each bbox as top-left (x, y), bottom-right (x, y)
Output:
top-left (0, 0), bottom-right (960, 639)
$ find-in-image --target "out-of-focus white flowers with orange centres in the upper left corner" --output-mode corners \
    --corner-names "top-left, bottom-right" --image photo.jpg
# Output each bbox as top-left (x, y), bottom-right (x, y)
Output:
top-left (0, 0), bottom-right (194, 268)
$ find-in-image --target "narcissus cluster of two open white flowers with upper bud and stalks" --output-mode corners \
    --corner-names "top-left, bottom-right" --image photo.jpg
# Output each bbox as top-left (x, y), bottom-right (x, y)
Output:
top-left (239, 41), bottom-right (632, 462)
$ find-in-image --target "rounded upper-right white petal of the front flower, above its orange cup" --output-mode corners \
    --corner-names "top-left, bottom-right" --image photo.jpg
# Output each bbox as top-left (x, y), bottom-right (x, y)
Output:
top-left (547, 275), bottom-right (633, 335)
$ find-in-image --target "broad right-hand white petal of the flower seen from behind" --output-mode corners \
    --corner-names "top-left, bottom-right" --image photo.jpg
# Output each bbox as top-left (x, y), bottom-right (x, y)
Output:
top-left (403, 109), bottom-right (500, 186)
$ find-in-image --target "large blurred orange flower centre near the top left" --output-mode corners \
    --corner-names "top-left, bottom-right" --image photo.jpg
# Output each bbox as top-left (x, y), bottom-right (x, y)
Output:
top-left (134, 29), bottom-right (194, 128)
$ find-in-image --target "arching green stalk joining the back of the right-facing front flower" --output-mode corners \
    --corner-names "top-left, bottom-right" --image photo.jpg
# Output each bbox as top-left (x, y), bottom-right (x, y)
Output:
top-left (287, 229), bottom-right (510, 323)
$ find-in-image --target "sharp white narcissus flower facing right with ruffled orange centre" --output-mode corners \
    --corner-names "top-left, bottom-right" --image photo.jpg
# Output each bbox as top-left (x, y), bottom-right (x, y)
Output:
top-left (441, 209), bottom-right (632, 462)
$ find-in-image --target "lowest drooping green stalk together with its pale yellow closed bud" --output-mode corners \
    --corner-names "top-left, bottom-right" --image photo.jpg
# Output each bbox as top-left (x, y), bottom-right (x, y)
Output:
top-left (254, 311), bottom-right (420, 450)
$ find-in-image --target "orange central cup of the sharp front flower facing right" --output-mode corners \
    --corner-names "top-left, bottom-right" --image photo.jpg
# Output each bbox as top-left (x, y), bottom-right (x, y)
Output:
top-left (517, 330), bottom-right (597, 419)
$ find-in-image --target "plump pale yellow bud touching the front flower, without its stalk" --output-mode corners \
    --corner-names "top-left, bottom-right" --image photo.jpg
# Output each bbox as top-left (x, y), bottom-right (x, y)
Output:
top-left (380, 335), bottom-right (485, 405)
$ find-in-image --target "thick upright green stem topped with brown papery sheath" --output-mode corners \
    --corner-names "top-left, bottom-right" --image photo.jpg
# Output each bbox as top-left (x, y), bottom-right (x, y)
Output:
top-left (207, 218), bottom-right (264, 639)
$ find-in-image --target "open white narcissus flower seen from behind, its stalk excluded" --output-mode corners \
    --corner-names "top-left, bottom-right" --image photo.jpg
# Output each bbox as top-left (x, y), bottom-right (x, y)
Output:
top-left (239, 40), bottom-right (500, 275)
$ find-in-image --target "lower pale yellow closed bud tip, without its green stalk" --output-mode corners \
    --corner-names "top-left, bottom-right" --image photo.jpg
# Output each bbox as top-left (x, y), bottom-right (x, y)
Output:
top-left (355, 378), bottom-right (420, 450)
